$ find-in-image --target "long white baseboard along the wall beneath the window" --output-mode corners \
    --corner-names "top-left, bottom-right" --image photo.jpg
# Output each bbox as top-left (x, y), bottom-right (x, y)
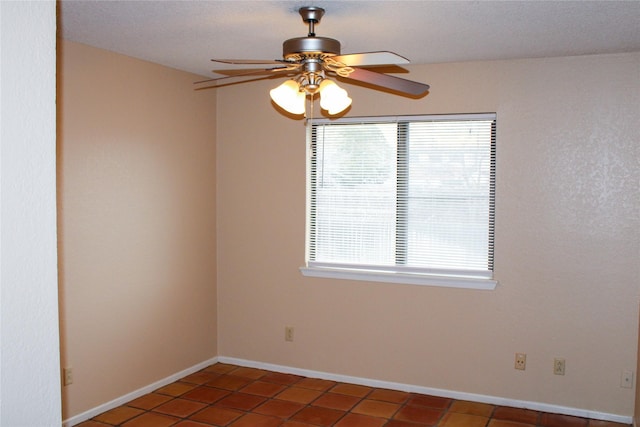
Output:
top-left (218, 356), bottom-right (639, 427)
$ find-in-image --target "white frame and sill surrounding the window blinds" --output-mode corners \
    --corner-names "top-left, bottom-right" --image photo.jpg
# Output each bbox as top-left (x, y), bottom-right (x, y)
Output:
top-left (300, 113), bottom-right (498, 290)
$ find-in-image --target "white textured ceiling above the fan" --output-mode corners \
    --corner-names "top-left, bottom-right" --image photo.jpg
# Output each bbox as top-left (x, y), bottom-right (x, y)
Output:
top-left (60, 0), bottom-right (640, 77)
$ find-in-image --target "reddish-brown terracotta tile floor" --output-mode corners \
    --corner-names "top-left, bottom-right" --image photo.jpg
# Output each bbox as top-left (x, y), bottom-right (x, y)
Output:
top-left (78, 363), bottom-right (627, 427)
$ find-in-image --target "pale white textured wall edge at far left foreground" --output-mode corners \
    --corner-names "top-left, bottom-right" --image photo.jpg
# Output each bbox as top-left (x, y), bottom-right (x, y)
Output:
top-left (0, 1), bottom-right (61, 427)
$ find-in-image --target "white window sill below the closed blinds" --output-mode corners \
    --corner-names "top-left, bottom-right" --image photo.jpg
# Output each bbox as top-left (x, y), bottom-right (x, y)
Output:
top-left (300, 267), bottom-right (498, 290)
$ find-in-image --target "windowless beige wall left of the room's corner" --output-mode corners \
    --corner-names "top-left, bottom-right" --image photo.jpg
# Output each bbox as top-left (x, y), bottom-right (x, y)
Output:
top-left (58, 42), bottom-right (217, 419)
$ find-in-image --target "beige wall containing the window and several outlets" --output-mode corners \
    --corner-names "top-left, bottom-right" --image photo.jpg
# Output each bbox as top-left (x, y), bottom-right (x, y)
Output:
top-left (217, 54), bottom-right (640, 417)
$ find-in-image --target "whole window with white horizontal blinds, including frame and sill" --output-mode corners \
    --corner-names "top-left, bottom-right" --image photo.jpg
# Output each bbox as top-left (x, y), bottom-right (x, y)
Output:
top-left (301, 114), bottom-right (496, 289)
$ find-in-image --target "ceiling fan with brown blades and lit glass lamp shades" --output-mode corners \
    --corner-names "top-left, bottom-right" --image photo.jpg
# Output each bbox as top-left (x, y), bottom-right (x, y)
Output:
top-left (195, 6), bottom-right (429, 115)
